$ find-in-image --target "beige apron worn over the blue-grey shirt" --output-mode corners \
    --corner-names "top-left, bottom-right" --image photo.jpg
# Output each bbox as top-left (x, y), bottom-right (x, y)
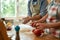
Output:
top-left (30, 0), bottom-right (40, 16)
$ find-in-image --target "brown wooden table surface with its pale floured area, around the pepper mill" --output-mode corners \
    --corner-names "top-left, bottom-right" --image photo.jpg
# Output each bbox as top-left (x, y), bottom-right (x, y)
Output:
top-left (8, 24), bottom-right (60, 40)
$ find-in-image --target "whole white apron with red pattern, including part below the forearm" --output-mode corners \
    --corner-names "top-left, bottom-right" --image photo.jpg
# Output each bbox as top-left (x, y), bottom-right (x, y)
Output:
top-left (46, 2), bottom-right (60, 38)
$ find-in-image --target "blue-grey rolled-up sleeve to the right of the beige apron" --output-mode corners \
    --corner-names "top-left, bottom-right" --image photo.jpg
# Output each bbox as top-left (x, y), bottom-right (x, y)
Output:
top-left (40, 0), bottom-right (48, 16)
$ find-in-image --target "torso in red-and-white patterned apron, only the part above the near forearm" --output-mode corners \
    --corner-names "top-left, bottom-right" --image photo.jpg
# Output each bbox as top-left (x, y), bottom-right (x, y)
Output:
top-left (47, 0), bottom-right (60, 22)
